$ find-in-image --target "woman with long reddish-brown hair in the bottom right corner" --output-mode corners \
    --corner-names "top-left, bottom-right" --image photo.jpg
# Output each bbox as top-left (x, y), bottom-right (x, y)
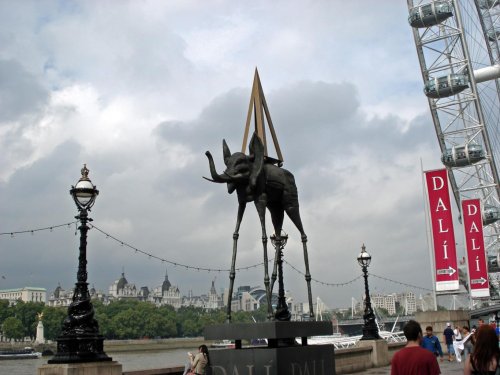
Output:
top-left (464, 325), bottom-right (500, 375)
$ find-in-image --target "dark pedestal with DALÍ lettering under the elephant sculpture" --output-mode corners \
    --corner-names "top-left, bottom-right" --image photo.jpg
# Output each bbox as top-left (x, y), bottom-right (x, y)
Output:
top-left (205, 321), bottom-right (335, 375)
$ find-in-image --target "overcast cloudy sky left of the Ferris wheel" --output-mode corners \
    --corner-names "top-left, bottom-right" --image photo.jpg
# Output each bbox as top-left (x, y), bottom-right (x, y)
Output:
top-left (0, 0), bottom-right (459, 307)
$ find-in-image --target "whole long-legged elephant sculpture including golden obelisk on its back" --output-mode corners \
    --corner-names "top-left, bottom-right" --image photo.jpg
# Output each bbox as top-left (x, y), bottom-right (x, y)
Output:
top-left (205, 69), bottom-right (314, 322)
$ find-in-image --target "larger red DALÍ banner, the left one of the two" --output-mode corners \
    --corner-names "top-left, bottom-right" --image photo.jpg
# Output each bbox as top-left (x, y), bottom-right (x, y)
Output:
top-left (425, 169), bottom-right (458, 292)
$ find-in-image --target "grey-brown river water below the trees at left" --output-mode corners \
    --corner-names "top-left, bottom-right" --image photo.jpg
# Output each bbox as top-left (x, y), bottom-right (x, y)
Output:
top-left (0, 348), bottom-right (189, 375)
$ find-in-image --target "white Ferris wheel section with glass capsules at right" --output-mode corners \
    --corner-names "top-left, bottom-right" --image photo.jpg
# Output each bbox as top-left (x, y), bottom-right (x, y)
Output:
top-left (407, 0), bottom-right (500, 299)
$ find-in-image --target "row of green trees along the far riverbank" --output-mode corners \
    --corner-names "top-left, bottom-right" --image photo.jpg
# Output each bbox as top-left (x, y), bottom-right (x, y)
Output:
top-left (0, 300), bottom-right (267, 341)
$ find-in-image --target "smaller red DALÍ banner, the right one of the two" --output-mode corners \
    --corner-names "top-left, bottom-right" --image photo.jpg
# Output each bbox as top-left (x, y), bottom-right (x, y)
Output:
top-left (462, 199), bottom-right (490, 297)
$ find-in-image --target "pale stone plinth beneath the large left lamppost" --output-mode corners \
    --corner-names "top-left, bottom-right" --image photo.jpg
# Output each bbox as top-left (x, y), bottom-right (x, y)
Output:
top-left (37, 361), bottom-right (122, 375)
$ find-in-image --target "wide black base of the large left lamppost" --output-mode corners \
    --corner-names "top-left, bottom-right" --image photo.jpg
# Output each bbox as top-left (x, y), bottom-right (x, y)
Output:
top-left (47, 335), bottom-right (112, 364)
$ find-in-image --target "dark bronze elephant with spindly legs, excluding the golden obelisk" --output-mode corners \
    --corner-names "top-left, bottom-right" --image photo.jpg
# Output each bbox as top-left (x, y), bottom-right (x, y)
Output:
top-left (205, 133), bottom-right (314, 321)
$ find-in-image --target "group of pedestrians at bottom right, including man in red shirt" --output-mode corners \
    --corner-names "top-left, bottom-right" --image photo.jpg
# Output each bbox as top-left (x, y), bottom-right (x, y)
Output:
top-left (391, 319), bottom-right (500, 375)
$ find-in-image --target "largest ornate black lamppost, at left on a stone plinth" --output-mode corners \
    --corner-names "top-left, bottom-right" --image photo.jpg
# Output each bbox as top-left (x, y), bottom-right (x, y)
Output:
top-left (48, 164), bottom-right (111, 364)
